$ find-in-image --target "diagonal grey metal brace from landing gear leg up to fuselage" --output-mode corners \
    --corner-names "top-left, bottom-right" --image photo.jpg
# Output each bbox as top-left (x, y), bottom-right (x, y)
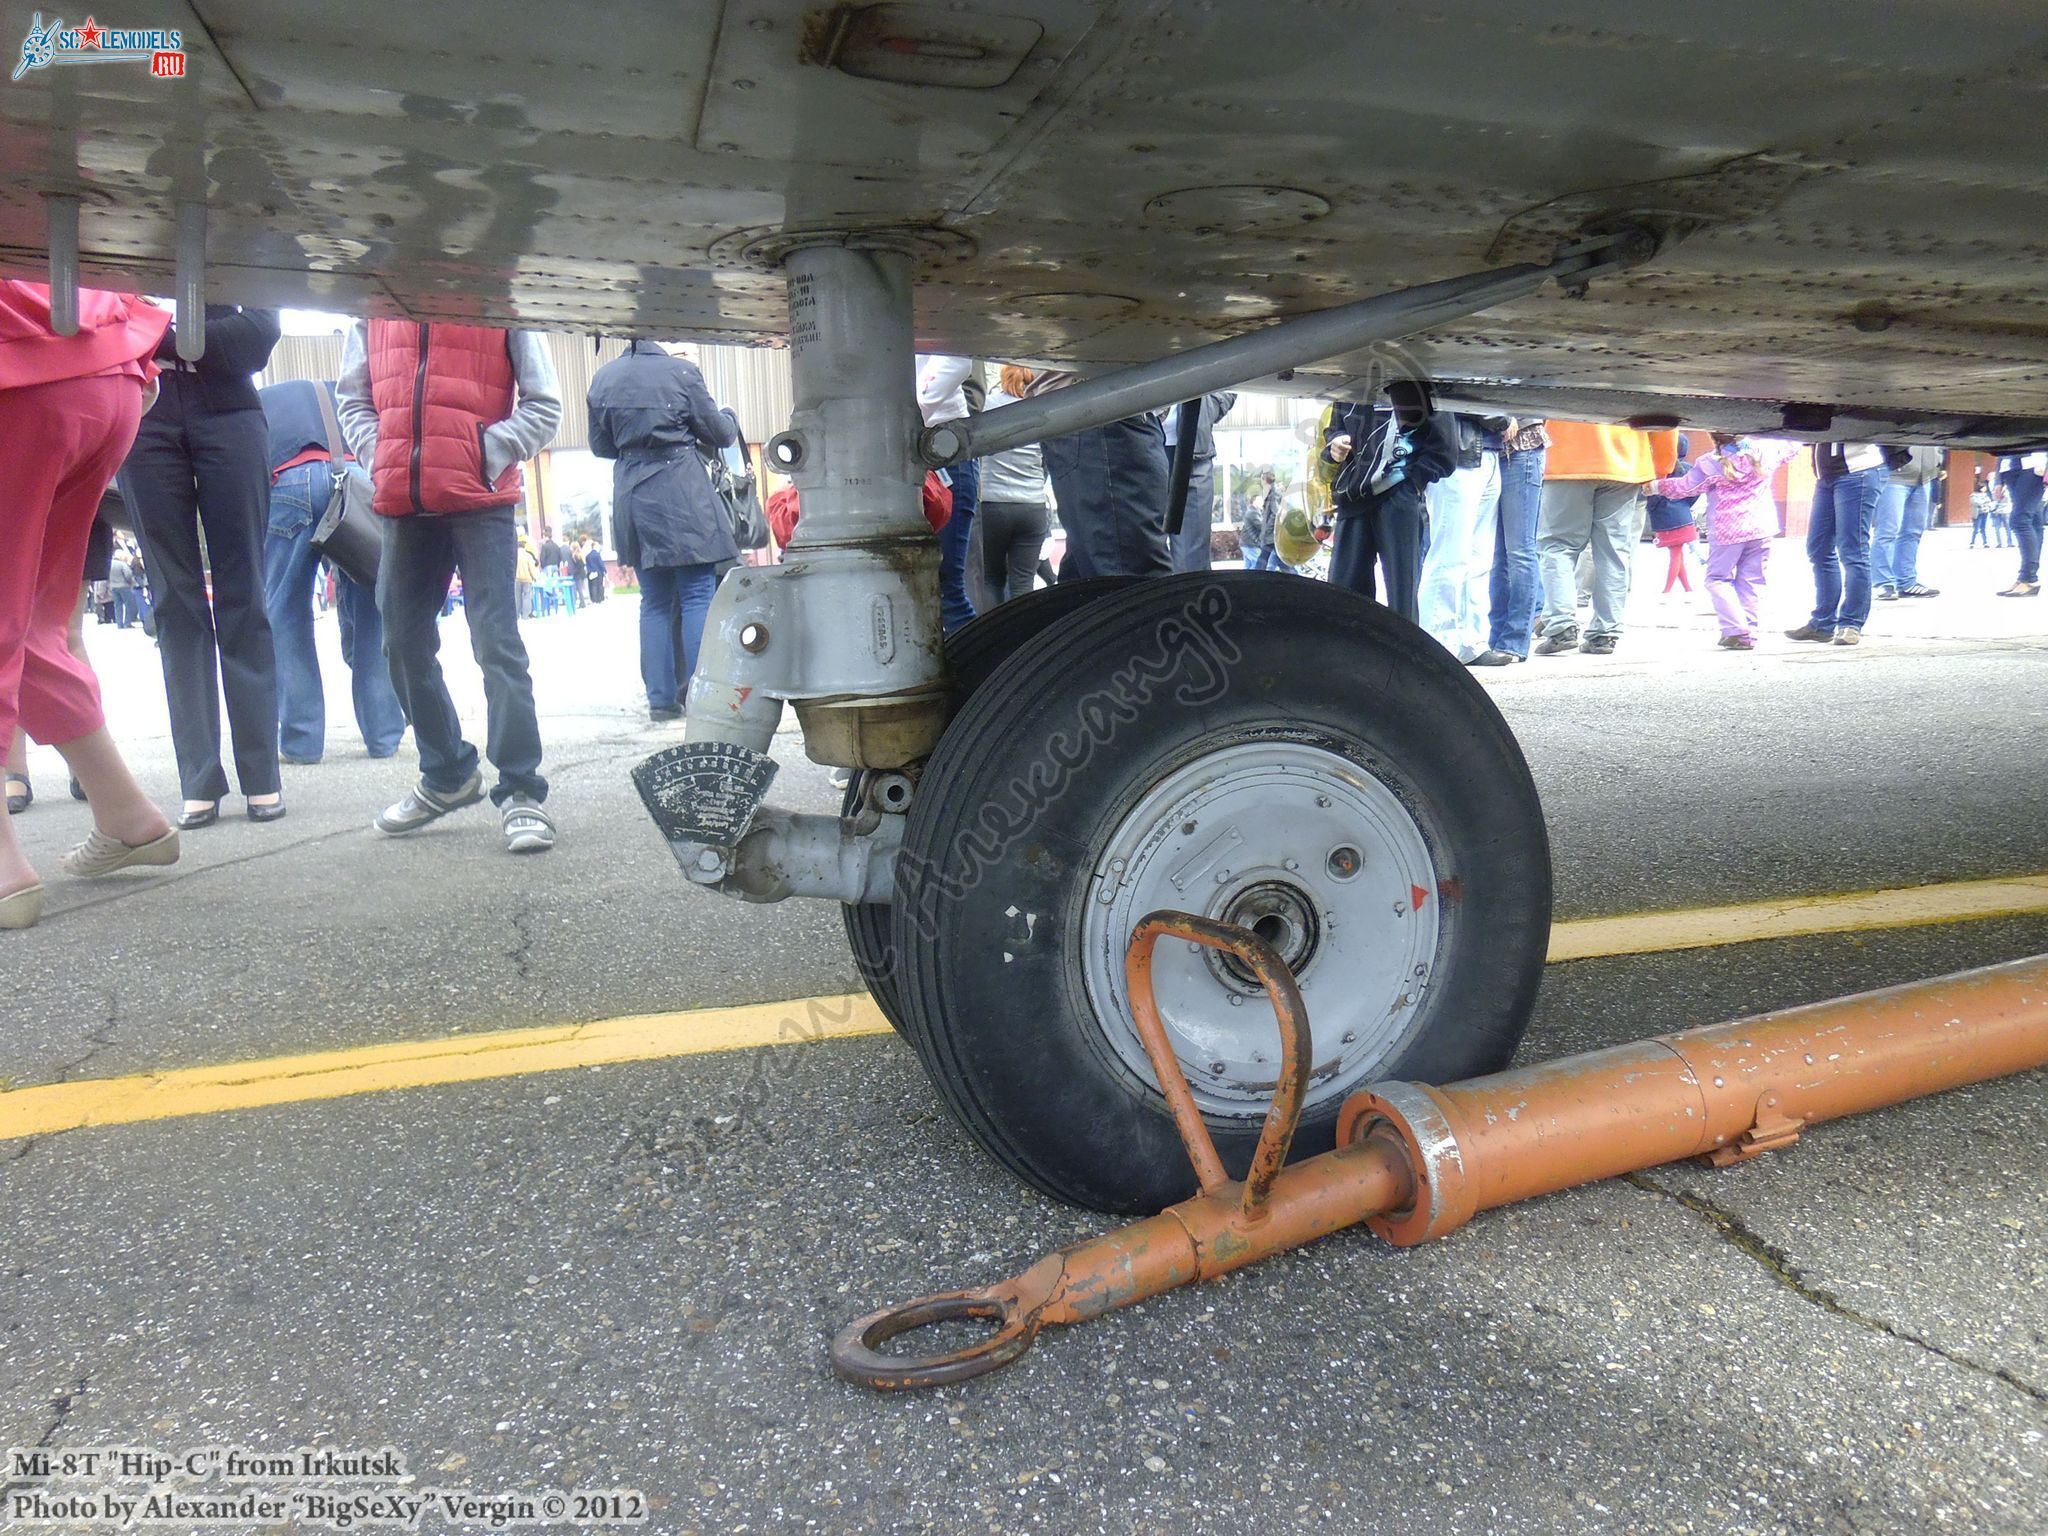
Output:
top-left (920, 225), bottom-right (1659, 469)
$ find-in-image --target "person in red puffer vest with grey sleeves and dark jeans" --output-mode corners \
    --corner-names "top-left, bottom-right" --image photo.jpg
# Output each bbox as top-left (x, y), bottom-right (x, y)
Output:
top-left (336, 319), bottom-right (561, 854)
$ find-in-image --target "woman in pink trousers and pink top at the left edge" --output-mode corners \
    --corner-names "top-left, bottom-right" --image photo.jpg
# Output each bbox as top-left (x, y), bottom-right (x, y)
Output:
top-left (0, 281), bottom-right (178, 930)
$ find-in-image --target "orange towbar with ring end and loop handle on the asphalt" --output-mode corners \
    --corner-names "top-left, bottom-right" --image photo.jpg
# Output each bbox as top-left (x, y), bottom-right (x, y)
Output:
top-left (831, 911), bottom-right (2048, 1389)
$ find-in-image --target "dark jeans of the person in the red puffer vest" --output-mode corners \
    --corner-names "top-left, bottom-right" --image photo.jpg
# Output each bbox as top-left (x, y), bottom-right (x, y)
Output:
top-left (377, 506), bottom-right (547, 805)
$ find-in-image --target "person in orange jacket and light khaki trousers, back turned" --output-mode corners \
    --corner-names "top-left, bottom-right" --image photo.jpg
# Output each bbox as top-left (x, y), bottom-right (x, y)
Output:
top-left (1536, 422), bottom-right (1677, 655)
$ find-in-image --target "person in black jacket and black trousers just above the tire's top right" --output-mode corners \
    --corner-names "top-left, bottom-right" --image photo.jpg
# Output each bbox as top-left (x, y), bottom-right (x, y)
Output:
top-left (1323, 379), bottom-right (1458, 623)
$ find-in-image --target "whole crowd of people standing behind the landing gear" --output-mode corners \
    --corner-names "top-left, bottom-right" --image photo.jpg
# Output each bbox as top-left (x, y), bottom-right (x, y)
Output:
top-left (0, 281), bottom-right (2048, 928)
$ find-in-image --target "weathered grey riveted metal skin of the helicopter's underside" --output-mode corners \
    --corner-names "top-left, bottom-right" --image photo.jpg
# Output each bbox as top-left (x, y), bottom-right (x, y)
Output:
top-left (0, 0), bottom-right (2048, 442)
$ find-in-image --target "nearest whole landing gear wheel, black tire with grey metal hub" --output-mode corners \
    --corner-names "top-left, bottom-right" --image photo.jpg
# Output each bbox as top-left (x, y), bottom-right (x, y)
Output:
top-left (891, 571), bottom-right (1550, 1212)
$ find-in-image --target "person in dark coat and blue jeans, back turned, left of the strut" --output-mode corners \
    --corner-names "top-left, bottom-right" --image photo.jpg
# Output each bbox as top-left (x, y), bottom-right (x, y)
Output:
top-left (590, 342), bottom-right (739, 721)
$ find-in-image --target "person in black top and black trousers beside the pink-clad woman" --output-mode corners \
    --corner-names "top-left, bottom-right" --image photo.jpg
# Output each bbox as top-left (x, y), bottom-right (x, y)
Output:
top-left (121, 303), bottom-right (285, 831)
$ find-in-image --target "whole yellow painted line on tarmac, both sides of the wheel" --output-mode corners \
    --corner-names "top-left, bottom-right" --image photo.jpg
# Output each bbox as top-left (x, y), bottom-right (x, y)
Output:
top-left (0, 874), bottom-right (2048, 1141)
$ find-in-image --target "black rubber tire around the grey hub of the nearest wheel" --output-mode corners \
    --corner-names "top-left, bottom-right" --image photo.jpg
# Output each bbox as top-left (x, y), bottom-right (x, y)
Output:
top-left (891, 571), bottom-right (1550, 1212)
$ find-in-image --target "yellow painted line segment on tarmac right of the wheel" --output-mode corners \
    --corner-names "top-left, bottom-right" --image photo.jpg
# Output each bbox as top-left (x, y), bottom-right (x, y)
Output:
top-left (1550, 874), bottom-right (2048, 965)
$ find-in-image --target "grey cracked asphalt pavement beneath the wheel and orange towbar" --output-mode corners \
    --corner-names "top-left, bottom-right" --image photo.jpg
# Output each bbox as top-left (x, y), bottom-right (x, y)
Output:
top-left (0, 573), bottom-right (2048, 1536)
